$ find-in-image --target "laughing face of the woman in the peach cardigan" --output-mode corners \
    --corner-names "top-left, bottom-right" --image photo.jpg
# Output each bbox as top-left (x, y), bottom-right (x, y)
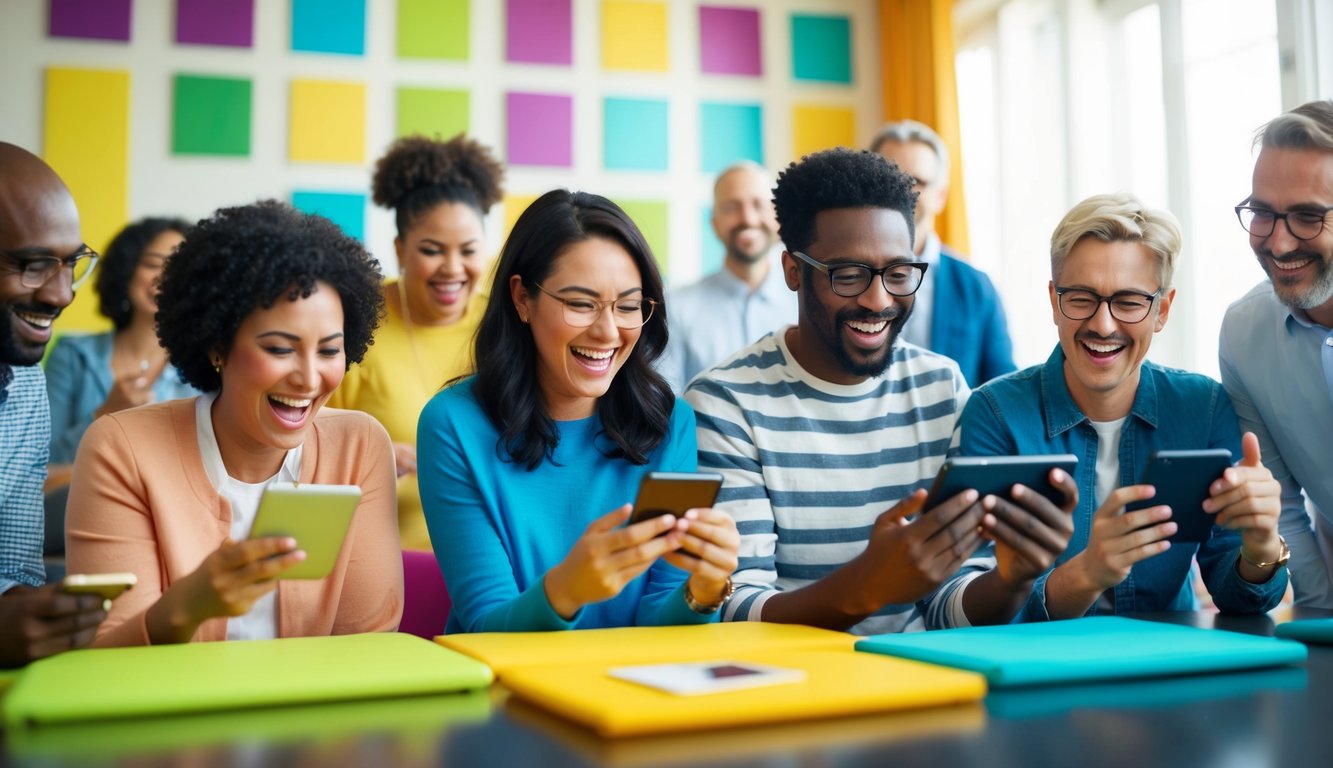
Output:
top-left (213, 283), bottom-right (347, 483)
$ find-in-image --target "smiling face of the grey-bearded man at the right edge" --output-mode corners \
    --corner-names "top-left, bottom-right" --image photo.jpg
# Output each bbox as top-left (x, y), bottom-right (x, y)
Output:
top-left (1246, 147), bottom-right (1333, 325)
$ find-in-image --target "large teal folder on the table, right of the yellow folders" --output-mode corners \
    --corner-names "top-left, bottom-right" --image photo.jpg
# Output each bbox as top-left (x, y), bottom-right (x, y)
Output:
top-left (856, 616), bottom-right (1308, 688)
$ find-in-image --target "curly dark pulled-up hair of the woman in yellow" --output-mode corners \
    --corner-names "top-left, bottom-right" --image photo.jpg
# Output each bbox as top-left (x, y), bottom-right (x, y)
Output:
top-left (371, 133), bottom-right (504, 236)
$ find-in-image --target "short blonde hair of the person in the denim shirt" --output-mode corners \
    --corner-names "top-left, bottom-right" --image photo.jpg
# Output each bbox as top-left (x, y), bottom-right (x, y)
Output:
top-left (1050, 192), bottom-right (1181, 291)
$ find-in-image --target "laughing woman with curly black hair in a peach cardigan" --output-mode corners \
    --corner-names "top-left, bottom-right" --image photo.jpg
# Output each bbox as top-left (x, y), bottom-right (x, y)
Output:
top-left (67, 201), bottom-right (403, 645)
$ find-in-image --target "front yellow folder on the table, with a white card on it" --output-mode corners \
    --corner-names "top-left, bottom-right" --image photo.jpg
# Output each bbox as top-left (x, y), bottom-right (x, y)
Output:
top-left (503, 647), bottom-right (986, 736)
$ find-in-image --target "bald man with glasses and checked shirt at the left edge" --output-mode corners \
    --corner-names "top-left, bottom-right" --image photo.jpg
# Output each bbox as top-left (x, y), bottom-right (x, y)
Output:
top-left (0, 143), bottom-right (107, 667)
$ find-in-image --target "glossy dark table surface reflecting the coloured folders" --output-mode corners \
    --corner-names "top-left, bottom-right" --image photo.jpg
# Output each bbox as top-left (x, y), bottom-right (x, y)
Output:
top-left (0, 611), bottom-right (1333, 768)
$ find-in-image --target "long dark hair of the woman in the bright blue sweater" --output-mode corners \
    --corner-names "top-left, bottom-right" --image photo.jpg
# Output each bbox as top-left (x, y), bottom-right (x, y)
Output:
top-left (472, 189), bottom-right (676, 471)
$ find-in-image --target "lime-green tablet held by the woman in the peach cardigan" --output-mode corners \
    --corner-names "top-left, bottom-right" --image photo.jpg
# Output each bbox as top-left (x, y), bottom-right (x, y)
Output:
top-left (249, 483), bottom-right (361, 579)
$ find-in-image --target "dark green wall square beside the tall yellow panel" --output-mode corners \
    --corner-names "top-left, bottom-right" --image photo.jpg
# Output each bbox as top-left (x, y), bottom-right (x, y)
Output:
top-left (171, 75), bottom-right (252, 157)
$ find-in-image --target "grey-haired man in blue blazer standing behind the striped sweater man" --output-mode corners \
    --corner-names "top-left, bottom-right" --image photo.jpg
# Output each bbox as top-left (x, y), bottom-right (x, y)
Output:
top-left (870, 120), bottom-right (1014, 387)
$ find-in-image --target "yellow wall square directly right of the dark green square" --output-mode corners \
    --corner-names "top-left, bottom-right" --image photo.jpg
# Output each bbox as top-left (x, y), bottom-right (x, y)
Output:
top-left (288, 80), bottom-right (365, 163)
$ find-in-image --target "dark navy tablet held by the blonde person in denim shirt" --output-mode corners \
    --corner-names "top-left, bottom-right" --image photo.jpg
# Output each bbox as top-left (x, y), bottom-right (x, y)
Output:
top-left (1125, 448), bottom-right (1232, 544)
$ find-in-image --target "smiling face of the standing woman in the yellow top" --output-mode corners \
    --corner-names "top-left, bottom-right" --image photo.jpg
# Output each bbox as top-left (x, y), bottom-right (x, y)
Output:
top-left (393, 203), bottom-right (485, 325)
